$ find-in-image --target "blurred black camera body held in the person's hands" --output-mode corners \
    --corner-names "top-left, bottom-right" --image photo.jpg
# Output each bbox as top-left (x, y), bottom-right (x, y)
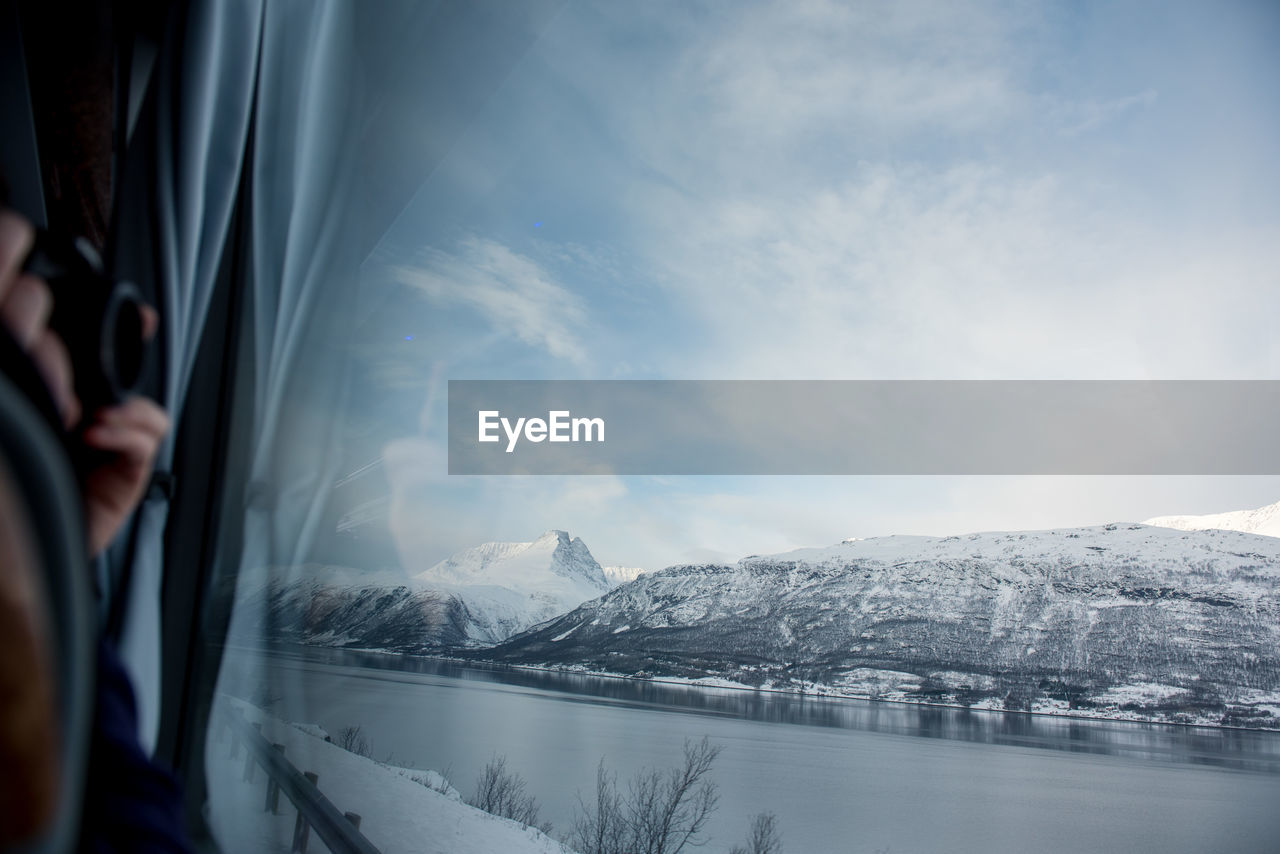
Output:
top-left (23, 230), bottom-right (150, 417)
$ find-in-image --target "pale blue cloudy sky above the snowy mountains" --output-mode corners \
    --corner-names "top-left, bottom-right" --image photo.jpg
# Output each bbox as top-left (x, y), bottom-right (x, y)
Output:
top-left (345, 0), bottom-right (1280, 571)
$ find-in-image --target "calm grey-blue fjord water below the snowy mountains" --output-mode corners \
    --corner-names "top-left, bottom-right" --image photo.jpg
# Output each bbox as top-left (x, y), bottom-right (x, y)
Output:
top-left (224, 648), bottom-right (1280, 854)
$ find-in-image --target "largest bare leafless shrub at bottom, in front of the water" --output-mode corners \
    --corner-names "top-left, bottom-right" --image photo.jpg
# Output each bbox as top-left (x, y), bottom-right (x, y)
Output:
top-left (570, 737), bottom-right (721, 854)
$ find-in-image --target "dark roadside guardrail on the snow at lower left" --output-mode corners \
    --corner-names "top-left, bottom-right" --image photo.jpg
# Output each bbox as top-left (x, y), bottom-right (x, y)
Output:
top-left (221, 705), bottom-right (381, 854)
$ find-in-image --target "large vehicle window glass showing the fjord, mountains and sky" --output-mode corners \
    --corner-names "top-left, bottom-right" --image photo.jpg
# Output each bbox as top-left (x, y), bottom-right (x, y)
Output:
top-left (206, 3), bottom-right (1280, 851)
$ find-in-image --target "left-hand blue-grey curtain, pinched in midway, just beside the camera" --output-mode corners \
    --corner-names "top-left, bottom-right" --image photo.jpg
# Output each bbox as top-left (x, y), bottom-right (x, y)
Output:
top-left (111, 0), bottom-right (262, 750)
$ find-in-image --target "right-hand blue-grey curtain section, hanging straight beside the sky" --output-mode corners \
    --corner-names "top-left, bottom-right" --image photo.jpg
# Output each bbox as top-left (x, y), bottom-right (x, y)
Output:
top-left (241, 1), bottom-right (361, 606)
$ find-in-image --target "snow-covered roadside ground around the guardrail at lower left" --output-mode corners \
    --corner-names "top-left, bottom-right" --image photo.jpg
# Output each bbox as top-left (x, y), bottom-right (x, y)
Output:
top-left (206, 697), bottom-right (572, 854)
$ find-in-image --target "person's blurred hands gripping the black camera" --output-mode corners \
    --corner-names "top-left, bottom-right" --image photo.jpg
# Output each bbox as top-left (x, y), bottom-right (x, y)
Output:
top-left (0, 210), bottom-right (169, 554)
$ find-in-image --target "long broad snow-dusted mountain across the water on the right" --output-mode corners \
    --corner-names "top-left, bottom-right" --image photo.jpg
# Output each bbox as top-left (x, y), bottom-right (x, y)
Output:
top-left (483, 525), bottom-right (1280, 725)
